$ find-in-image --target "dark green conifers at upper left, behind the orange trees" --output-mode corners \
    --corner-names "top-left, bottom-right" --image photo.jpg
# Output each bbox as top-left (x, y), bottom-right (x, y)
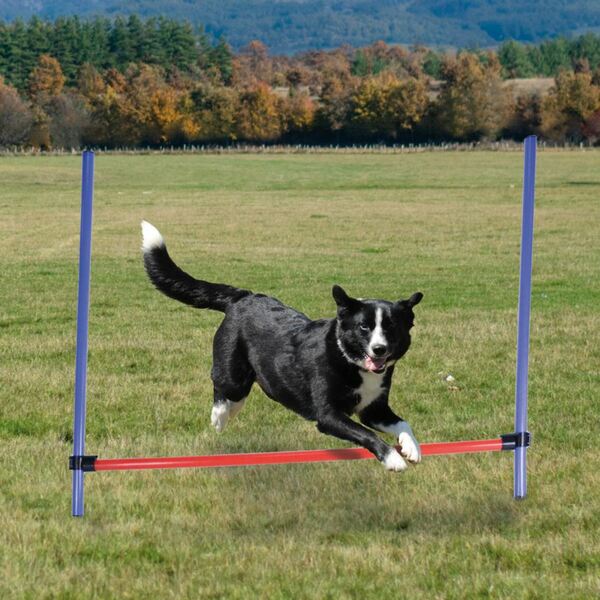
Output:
top-left (0, 15), bottom-right (232, 92)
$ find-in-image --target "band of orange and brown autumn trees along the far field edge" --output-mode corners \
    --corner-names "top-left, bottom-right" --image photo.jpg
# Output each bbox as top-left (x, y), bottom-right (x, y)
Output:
top-left (5, 41), bottom-right (600, 148)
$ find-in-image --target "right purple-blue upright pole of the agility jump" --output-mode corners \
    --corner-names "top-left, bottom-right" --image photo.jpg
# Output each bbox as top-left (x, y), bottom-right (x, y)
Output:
top-left (514, 135), bottom-right (537, 499)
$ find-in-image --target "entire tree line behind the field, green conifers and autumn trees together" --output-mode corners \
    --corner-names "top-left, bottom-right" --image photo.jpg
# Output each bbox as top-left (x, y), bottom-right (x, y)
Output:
top-left (0, 16), bottom-right (600, 149)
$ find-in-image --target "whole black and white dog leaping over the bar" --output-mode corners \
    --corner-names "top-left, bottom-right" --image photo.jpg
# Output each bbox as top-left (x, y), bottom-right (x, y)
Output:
top-left (142, 221), bottom-right (423, 471)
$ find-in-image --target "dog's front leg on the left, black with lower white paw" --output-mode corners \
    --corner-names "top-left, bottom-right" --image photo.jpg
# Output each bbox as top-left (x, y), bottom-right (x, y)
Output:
top-left (317, 411), bottom-right (407, 471)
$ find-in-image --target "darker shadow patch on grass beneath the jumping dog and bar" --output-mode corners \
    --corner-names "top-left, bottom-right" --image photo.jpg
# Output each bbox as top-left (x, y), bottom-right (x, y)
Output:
top-left (203, 465), bottom-right (518, 542)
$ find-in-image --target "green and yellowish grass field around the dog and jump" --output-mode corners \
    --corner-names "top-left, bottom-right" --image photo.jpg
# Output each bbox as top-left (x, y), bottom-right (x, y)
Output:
top-left (0, 152), bottom-right (600, 600)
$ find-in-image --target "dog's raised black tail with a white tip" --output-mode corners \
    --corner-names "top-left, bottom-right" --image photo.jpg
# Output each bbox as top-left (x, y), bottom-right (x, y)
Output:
top-left (142, 221), bottom-right (251, 312)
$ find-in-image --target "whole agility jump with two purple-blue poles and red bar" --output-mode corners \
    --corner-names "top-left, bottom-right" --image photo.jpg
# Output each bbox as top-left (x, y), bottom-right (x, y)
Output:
top-left (69, 136), bottom-right (537, 517)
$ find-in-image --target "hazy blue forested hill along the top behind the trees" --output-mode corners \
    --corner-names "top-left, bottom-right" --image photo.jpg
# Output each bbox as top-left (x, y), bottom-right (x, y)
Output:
top-left (0, 0), bottom-right (600, 54)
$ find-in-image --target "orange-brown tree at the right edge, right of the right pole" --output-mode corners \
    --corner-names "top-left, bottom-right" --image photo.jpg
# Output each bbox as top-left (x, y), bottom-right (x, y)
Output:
top-left (541, 71), bottom-right (600, 142)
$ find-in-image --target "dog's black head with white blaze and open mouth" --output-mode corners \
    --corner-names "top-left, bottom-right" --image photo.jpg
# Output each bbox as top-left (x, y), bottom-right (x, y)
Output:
top-left (332, 285), bottom-right (423, 373)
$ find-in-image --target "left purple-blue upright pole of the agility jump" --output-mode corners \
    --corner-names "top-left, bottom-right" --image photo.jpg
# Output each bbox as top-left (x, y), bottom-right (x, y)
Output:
top-left (72, 151), bottom-right (94, 517)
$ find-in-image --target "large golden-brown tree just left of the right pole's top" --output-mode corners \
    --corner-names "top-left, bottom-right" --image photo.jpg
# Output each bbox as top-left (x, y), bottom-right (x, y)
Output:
top-left (436, 52), bottom-right (512, 141)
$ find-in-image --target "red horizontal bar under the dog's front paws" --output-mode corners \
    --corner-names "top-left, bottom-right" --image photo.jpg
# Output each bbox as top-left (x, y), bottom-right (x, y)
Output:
top-left (92, 438), bottom-right (507, 471)
